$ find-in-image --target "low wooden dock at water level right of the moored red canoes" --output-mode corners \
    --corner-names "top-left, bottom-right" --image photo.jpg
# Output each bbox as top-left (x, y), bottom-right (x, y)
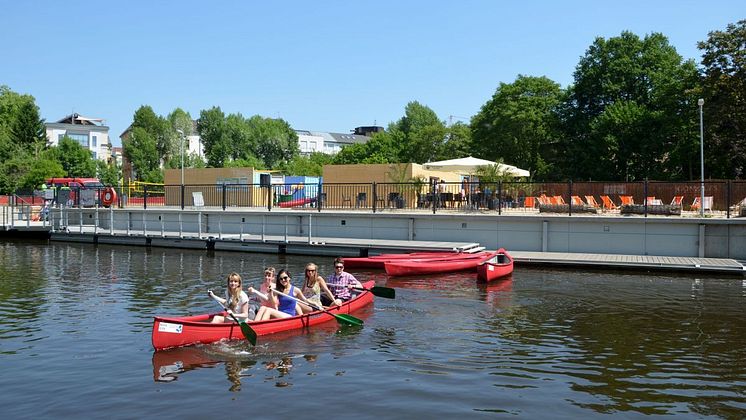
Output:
top-left (510, 251), bottom-right (746, 275)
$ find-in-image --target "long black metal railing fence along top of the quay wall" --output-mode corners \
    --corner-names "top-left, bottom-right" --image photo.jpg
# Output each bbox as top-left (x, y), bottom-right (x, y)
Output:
top-left (5, 181), bottom-right (746, 217)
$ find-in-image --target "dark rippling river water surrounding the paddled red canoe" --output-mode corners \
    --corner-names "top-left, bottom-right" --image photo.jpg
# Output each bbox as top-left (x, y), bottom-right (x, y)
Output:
top-left (0, 242), bottom-right (746, 419)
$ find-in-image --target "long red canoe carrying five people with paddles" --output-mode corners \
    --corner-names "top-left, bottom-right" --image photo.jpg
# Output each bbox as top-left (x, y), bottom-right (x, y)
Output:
top-left (152, 280), bottom-right (375, 350)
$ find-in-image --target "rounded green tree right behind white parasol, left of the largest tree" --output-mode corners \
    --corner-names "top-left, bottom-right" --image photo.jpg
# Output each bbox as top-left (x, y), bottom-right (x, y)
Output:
top-left (471, 75), bottom-right (563, 179)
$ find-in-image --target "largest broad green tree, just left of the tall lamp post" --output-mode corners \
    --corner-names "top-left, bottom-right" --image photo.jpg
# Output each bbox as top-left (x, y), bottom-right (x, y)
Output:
top-left (556, 32), bottom-right (696, 180)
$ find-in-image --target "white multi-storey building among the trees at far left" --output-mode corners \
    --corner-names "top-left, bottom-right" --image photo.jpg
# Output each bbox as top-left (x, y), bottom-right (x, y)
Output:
top-left (44, 114), bottom-right (111, 161)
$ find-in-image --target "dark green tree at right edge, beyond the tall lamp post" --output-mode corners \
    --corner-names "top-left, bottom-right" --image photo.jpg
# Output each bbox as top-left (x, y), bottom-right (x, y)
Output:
top-left (690, 20), bottom-right (746, 179)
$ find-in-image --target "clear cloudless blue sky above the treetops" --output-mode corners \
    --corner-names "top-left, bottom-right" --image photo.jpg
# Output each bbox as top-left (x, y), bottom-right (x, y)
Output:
top-left (0, 0), bottom-right (746, 145)
